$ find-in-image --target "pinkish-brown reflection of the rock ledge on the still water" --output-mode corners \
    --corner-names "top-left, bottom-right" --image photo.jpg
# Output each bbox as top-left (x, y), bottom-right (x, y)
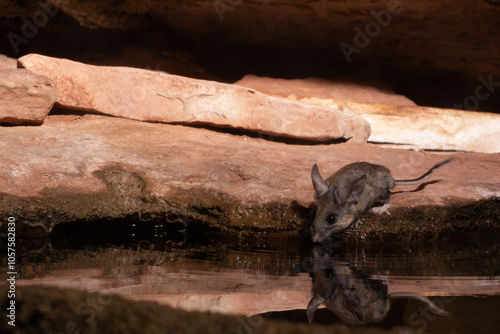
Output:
top-left (10, 242), bottom-right (500, 322)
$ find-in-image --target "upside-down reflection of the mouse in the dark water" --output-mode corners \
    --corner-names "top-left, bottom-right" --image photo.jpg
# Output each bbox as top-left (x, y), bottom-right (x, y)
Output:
top-left (307, 247), bottom-right (448, 326)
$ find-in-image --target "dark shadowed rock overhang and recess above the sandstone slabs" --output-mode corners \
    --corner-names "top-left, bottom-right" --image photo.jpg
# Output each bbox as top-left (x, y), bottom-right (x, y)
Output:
top-left (0, 0), bottom-right (500, 112)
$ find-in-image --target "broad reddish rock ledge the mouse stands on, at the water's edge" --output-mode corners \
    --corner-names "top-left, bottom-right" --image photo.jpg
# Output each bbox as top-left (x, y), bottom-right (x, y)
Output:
top-left (0, 116), bottom-right (500, 229)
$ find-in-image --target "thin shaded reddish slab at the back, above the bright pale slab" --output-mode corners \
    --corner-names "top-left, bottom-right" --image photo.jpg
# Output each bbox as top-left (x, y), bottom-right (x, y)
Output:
top-left (235, 74), bottom-right (416, 106)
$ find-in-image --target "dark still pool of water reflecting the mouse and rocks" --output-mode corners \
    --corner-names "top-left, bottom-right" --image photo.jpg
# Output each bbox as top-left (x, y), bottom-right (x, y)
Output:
top-left (6, 219), bottom-right (500, 333)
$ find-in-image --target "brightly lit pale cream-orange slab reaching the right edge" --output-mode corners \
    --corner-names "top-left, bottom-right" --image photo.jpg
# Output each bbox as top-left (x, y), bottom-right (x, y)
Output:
top-left (294, 98), bottom-right (500, 153)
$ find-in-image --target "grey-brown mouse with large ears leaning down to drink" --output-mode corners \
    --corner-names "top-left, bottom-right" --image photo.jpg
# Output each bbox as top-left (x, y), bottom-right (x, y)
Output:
top-left (311, 159), bottom-right (452, 242)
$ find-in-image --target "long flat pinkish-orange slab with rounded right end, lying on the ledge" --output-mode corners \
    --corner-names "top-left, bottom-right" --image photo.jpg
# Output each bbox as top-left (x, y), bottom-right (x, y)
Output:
top-left (19, 54), bottom-right (370, 142)
